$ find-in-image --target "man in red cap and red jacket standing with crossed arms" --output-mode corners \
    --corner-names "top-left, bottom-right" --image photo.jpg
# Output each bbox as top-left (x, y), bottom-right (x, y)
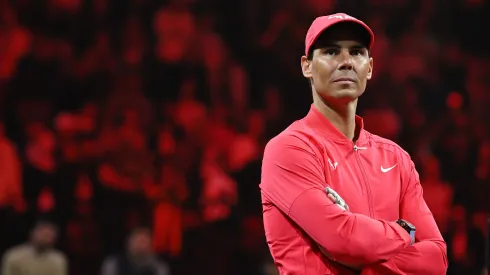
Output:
top-left (260, 14), bottom-right (447, 275)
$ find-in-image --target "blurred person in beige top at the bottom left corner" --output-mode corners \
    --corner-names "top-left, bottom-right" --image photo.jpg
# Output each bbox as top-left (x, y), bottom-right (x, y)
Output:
top-left (1, 220), bottom-right (68, 275)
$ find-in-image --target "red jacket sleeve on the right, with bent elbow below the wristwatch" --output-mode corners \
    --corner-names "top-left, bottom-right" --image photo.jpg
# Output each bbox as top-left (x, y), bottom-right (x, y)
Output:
top-left (362, 159), bottom-right (448, 275)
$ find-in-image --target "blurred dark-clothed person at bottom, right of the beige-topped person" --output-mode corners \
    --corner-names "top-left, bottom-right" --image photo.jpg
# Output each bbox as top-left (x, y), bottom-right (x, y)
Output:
top-left (101, 228), bottom-right (170, 275)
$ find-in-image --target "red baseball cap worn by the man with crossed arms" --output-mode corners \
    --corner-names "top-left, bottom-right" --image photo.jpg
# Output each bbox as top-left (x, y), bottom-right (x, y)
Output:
top-left (305, 13), bottom-right (374, 55)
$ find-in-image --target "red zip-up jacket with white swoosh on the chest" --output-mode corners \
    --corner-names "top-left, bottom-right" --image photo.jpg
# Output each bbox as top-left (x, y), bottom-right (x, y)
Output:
top-left (260, 105), bottom-right (447, 275)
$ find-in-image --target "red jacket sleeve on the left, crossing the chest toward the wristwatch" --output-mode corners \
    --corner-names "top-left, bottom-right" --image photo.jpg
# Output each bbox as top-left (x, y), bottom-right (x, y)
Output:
top-left (260, 136), bottom-right (410, 265)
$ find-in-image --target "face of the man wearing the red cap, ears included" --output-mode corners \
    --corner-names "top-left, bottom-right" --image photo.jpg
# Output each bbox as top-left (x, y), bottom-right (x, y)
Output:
top-left (301, 23), bottom-right (373, 104)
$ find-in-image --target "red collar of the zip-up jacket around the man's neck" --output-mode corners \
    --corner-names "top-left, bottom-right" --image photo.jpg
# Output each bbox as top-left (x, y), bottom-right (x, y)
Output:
top-left (304, 104), bottom-right (367, 144)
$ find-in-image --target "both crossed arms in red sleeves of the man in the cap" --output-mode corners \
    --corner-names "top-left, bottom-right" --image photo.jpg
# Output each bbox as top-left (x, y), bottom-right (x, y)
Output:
top-left (261, 136), bottom-right (447, 275)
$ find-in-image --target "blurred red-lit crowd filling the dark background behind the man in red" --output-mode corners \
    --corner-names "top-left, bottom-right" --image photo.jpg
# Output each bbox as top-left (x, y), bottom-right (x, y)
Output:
top-left (0, 0), bottom-right (490, 275)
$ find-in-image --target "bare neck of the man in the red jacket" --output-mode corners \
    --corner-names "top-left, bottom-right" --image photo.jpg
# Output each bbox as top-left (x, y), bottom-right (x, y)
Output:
top-left (313, 99), bottom-right (358, 140)
